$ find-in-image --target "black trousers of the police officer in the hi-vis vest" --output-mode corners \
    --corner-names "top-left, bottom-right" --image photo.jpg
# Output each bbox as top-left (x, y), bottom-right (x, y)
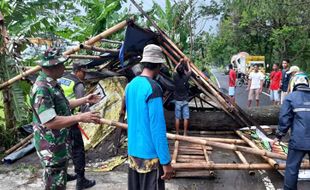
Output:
top-left (70, 124), bottom-right (85, 177)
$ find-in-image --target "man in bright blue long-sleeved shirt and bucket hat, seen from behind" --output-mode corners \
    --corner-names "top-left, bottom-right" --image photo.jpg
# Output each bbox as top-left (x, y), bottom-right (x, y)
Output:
top-left (125, 44), bottom-right (173, 190)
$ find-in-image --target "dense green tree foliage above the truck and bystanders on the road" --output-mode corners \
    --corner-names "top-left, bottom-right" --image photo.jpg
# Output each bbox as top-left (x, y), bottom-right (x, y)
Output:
top-left (207, 0), bottom-right (310, 72)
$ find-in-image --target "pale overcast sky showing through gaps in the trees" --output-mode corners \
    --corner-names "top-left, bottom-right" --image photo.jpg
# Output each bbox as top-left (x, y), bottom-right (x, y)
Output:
top-left (125, 0), bottom-right (219, 33)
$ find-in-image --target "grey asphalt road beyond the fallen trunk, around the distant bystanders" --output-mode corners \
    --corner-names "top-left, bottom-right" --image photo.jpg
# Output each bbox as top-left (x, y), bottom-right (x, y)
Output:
top-left (211, 69), bottom-right (271, 108)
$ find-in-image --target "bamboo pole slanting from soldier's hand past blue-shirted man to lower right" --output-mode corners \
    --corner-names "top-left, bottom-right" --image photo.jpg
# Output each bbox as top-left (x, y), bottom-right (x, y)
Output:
top-left (101, 118), bottom-right (286, 160)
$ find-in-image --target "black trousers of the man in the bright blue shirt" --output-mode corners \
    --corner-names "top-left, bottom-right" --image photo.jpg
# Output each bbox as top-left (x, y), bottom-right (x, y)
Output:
top-left (128, 166), bottom-right (165, 190)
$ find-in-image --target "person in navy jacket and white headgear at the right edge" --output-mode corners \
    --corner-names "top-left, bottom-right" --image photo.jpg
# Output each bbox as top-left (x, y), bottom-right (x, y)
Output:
top-left (274, 75), bottom-right (310, 190)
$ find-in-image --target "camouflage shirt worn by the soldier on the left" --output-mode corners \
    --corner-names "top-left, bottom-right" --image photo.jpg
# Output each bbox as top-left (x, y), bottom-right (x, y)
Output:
top-left (31, 72), bottom-right (71, 166)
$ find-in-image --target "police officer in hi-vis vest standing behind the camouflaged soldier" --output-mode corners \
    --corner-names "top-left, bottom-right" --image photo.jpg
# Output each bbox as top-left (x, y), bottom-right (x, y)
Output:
top-left (58, 63), bottom-right (96, 190)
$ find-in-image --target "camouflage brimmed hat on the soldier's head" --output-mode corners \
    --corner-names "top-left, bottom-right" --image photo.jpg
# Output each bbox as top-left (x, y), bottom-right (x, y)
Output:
top-left (38, 48), bottom-right (68, 67)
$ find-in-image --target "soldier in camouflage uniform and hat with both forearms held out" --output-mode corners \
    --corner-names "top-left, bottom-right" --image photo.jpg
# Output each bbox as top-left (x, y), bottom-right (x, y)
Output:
top-left (32, 49), bottom-right (100, 190)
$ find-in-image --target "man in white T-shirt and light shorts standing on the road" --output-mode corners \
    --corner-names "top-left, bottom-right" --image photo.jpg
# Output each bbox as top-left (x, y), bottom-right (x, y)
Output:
top-left (247, 65), bottom-right (264, 107)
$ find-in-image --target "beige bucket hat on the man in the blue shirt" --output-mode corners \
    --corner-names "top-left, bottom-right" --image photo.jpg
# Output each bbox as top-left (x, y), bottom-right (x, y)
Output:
top-left (141, 44), bottom-right (166, 63)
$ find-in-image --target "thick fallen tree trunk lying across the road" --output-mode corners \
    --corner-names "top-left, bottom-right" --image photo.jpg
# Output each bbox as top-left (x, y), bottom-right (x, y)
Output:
top-left (165, 106), bottom-right (280, 131)
